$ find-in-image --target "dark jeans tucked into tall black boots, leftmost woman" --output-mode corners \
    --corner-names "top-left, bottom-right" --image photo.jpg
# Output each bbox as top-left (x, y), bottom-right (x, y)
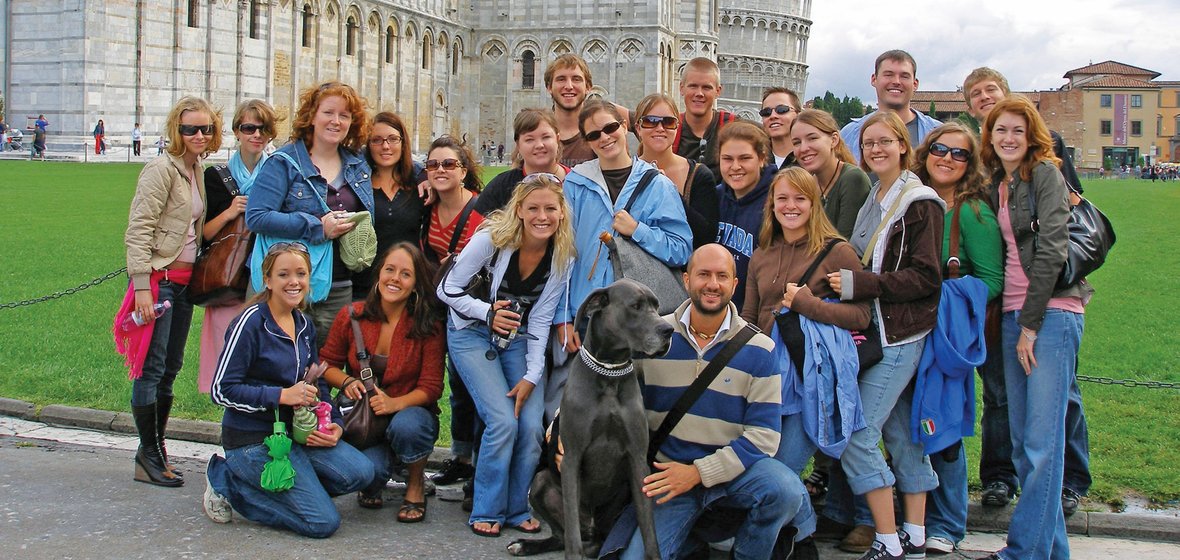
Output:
top-left (131, 279), bottom-right (192, 407)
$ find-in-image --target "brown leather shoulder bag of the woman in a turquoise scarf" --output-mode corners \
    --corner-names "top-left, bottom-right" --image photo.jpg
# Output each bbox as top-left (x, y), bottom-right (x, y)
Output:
top-left (188, 165), bottom-right (254, 307)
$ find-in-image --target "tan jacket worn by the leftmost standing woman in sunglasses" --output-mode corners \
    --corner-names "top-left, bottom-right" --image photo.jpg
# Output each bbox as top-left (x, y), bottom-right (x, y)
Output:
top-left (123, 153), bottom-right (205, 290)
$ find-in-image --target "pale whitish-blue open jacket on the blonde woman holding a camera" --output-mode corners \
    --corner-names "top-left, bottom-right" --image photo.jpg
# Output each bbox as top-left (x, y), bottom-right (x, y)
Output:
top-left (437, 229), bottom-right (573, 386)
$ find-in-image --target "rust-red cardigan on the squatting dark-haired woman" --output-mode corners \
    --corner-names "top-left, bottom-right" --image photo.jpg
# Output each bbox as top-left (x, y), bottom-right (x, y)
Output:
top-left (320, 302), bottom-right (446, 414)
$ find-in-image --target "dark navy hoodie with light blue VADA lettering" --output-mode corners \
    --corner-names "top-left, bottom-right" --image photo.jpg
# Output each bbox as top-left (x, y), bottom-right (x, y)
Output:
top-left (716, 162), bottom-right (774, 309)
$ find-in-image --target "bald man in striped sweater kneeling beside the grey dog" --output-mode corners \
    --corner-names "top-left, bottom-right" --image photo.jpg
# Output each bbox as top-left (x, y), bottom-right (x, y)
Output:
top-left (604, 244), bottom-right (809, 560)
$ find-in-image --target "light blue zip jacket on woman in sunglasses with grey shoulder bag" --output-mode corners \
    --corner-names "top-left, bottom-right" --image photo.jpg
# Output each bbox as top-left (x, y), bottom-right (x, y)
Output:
top-left (553, 158), bottom-right (693, 324)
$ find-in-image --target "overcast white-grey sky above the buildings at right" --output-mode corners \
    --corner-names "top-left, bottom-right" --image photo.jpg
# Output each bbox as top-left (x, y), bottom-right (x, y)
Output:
top-left (806, 0), bottom-right (1180, 105)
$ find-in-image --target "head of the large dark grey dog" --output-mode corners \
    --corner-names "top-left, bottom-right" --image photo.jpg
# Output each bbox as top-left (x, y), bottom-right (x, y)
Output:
top-left (576, 278), bottom-right (673, 357)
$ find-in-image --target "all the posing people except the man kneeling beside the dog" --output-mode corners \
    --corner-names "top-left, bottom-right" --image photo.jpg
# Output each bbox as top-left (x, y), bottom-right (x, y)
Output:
top-left (120, 51), bottom-right (1090, 560)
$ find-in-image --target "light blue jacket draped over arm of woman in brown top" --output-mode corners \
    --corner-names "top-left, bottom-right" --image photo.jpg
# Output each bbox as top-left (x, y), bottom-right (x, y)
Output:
top-left (771, 308), bottom-right (865, 459)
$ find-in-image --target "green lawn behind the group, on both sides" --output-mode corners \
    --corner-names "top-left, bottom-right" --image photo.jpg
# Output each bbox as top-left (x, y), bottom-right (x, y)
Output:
top-left (0, 162), bottom-right (1180, 503)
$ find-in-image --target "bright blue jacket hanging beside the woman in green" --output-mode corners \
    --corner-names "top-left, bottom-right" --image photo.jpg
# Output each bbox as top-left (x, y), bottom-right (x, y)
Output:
top-left (910, 276), bottom-right (988, 455)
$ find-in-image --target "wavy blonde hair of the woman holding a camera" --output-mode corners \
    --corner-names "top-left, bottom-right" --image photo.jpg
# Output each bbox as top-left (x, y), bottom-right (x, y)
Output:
top-left (480, 173), bottom-right (576, 270)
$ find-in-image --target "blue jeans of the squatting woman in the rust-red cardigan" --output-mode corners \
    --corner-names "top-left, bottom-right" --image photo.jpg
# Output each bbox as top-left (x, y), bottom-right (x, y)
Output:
top-left (361, 407), bottom-right (439, 493)
